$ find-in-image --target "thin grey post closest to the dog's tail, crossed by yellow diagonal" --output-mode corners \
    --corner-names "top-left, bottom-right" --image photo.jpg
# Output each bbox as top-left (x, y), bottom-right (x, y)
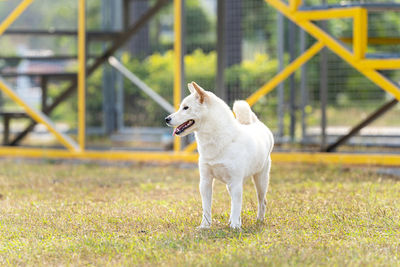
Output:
top-left (277, 12), bottom-right (285, 138)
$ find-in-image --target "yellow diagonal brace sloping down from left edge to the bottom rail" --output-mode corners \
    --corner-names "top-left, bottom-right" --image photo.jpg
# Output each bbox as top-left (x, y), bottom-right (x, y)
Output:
top-left (0, 80), bottom-right (78, 151)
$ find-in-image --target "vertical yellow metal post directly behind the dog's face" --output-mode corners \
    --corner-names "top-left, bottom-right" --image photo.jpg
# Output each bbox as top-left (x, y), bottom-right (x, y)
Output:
top-left (174, 0), bottom-right (182, 152)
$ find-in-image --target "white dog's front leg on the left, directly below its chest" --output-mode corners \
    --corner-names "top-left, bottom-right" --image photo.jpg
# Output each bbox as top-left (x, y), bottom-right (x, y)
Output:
top-left (199, 167), bottom-right (213, 228)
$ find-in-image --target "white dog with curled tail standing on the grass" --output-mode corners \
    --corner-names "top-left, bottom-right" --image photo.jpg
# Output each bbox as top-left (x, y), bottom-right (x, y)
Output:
top-left (165, 82), bottom-right (274, 229)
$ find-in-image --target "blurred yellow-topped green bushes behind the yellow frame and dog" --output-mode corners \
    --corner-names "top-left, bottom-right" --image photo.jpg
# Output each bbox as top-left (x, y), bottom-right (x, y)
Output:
top-left (61, 49), bottom-right (278, 129)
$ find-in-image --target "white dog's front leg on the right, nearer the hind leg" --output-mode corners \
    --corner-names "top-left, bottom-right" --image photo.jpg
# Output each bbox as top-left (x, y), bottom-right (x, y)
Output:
top-left (227, 181), bottom-right (243, 229)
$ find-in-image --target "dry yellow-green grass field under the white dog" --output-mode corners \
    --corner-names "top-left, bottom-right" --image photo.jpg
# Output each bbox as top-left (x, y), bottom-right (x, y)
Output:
top-left (0, 160), bottom-right (400, 266)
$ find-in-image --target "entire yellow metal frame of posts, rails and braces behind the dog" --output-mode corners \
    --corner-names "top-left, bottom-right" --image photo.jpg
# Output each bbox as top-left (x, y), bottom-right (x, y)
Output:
top-left (0, 0), bottom-right (400, 165)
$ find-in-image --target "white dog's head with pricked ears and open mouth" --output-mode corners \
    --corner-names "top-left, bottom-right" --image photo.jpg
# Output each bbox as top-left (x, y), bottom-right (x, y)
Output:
top-left (165, 82), bottom-right (210, 136)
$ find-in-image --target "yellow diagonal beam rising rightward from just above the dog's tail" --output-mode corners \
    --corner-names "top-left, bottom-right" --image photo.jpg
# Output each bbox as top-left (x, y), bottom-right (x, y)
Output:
top-left (246, 41), bottom-right (324, 106)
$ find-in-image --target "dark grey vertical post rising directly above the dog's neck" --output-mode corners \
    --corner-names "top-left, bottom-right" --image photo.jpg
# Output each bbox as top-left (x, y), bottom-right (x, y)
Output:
top-left (216, 0), bottom-right (227, 100)
